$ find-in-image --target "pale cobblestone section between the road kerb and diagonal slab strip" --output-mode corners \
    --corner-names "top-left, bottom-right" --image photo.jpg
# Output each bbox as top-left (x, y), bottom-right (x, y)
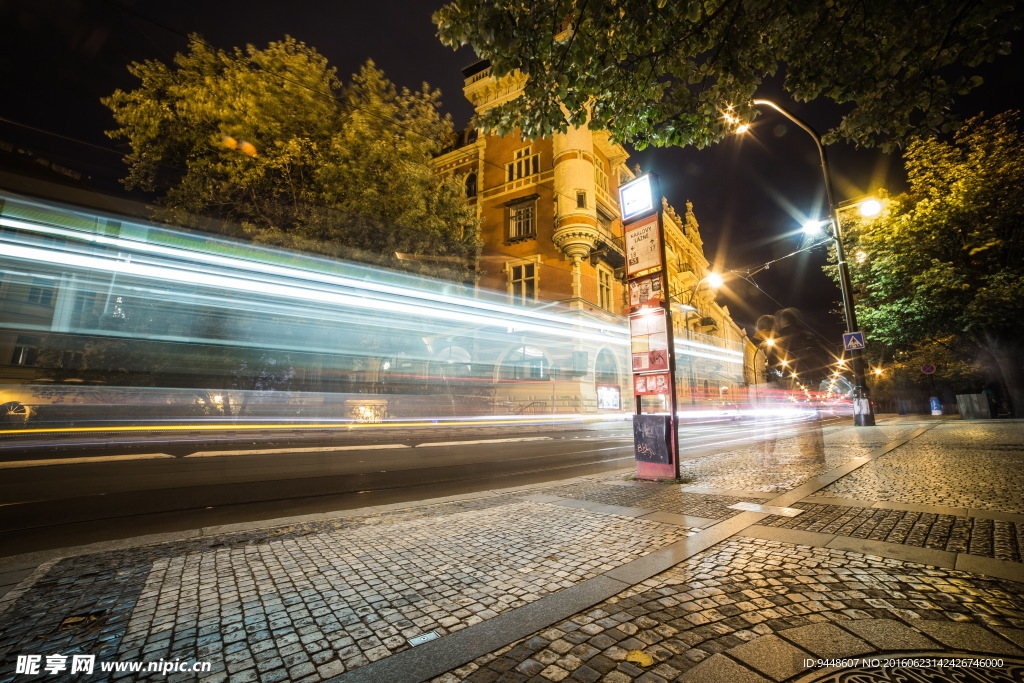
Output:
top-left (0, 497), bottom-right (692, 681)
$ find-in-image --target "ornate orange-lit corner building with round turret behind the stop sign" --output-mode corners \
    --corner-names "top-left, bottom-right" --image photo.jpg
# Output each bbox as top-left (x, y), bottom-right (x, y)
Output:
top-left (435, 61), bottom-right (749, 414)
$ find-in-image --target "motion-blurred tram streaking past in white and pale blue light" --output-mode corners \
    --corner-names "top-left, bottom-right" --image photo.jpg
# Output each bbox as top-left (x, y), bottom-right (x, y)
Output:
top-left (0, 193), bottom-right (744, 431)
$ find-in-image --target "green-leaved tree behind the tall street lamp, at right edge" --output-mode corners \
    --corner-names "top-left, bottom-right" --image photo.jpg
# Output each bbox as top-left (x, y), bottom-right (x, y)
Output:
top-left (833, 112), bottom-right (1024, 416)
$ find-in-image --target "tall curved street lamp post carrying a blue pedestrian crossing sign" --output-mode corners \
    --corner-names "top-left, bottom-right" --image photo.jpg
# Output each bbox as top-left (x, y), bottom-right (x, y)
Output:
top-left (754, 99), bottom-right (874, 427)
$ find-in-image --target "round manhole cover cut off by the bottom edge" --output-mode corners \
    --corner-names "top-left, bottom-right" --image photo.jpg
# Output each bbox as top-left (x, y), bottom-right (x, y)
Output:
top-left (791, 652), bottom-right (1024, 683)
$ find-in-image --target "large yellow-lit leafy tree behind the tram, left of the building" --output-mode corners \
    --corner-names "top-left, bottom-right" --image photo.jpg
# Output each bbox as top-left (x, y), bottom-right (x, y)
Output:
top-left (102, 36), bottom-right (479, 279)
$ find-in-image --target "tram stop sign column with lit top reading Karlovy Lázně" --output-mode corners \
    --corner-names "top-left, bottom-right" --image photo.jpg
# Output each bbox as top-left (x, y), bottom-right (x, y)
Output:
top-left (618, 173), bottom-right (679, 479)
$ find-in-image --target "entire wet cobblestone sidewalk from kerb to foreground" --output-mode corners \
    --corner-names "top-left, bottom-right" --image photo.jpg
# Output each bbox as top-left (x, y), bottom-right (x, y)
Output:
top-left (0, 420), bottom-right (1024, 683)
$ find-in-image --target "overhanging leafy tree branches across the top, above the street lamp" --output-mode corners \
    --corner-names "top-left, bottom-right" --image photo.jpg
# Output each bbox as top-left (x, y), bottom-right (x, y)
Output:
top-left (434, 0), bottom-right (1020, 148)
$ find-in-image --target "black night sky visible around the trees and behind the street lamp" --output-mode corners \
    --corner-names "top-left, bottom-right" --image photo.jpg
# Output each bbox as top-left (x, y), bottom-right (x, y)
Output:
top-left (0, 0), bottom-right (1022, 343)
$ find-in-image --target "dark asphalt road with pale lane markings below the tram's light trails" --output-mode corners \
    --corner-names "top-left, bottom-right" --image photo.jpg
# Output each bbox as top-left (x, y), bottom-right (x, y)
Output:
top-left (0, 421), bottom-right (811, 556)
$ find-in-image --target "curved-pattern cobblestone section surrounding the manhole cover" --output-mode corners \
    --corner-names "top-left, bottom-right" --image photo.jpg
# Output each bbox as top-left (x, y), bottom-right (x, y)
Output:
top-left (433, 540), bottom-right (1024, 683)
